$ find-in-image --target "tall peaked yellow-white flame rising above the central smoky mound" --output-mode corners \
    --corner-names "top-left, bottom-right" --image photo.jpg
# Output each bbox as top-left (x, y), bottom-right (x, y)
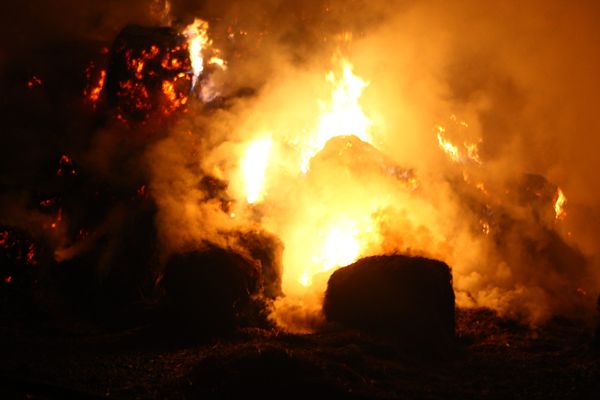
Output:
top-left (300, 58), bottom-right (372, 173)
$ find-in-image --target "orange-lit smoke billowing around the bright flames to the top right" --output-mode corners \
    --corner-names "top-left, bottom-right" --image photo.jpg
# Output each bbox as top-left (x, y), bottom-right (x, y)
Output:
top-left (143, 1), bottom-right (599, 325)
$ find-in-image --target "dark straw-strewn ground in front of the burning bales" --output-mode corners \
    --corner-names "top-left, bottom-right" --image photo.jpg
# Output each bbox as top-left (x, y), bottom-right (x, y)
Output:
top-left (0, 310), bottom-right (600, 399)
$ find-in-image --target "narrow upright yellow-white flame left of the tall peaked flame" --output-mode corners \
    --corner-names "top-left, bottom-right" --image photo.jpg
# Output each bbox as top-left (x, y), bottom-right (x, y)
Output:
top-left (242, 138), bottom-right (273, 204)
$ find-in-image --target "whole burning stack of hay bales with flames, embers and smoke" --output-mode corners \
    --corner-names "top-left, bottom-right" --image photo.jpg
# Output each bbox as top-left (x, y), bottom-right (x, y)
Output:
top-left (0, 0), bottom-right (597, 341)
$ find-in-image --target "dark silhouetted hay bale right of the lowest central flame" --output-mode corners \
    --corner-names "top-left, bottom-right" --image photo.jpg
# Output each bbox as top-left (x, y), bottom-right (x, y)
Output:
top-left (323, 255), bottom-right (455, 347)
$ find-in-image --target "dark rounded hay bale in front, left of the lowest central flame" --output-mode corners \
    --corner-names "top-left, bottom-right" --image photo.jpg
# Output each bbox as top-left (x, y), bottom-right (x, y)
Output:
top-left (162, 247), bottom-right (258, 332)
